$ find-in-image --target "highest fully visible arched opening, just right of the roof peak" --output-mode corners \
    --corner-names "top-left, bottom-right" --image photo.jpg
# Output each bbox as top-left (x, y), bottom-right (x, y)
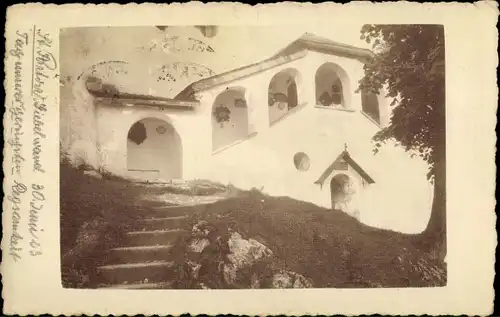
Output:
top-left (315, 63), bottom-right (350, 108)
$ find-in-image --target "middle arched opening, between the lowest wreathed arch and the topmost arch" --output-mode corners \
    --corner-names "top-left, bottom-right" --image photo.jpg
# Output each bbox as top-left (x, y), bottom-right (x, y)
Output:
top-left (268, 68), bottom-right (300, 123)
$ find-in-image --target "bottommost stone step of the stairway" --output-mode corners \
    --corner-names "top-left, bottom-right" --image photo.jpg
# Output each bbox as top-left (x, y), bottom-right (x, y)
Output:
top-left (98, 261), bottom-right (174, 285)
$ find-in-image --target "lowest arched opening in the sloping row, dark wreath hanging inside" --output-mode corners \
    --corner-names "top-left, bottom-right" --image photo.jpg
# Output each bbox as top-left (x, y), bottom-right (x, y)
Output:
top-left (212, 87), bottom-right (249, 150)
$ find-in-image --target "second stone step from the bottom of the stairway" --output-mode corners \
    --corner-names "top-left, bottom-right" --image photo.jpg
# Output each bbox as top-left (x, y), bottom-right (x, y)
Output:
top-left (106, 245), bottom-right (172, 264)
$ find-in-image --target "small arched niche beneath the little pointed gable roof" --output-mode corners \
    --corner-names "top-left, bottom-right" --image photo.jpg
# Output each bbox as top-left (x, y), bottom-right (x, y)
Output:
top-left (330, 174), bottom-right (359, 217)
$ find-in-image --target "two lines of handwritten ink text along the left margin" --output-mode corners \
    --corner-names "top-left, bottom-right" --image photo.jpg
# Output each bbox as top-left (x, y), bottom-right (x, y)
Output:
top-left (6, 26), bottom-right (53, 262)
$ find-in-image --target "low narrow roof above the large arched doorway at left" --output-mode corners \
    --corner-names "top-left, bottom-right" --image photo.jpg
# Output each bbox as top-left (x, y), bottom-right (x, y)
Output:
top-left (85, 77), bottom-right (199, 109)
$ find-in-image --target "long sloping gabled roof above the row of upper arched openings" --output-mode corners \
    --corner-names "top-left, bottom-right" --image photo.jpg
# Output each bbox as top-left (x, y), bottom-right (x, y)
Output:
top-left (175, 33), bottom-right (373, 100)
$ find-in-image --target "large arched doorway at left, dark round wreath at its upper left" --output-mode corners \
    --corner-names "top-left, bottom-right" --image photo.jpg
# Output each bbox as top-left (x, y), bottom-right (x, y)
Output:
top-left (127, 118), bottom-right (182, 179)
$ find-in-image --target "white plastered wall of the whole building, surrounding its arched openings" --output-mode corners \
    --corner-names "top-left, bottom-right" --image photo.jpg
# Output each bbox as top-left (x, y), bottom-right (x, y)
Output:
top-left (66, 43), bottom-right (432, 232)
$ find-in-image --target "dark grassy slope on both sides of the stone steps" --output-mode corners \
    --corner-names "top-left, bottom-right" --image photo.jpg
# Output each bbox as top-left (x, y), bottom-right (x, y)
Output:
top-left (60, 164), bottom-right (446, 287)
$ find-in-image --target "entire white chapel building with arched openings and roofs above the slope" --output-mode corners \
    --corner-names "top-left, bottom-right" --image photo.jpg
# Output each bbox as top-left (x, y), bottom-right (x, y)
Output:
top-left (61, 28), bottom-right (432, 232)
